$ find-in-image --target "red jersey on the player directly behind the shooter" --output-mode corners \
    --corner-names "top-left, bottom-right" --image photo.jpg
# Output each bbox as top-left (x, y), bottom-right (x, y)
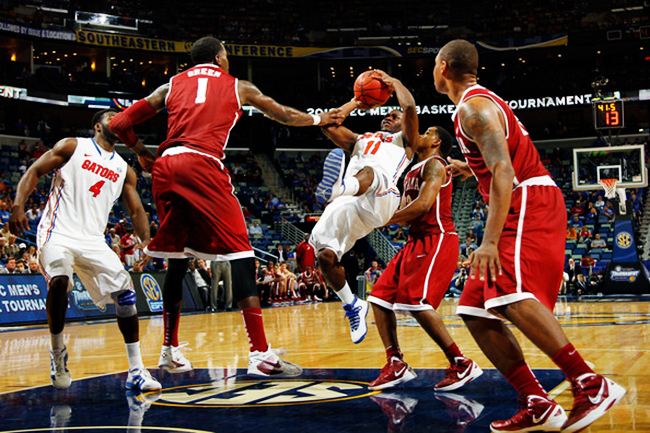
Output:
top-left (404, 156), bottom-right (456, 238)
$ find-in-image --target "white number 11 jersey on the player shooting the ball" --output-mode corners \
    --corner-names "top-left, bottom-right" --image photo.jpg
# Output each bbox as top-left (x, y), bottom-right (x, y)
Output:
top-left (345, 131), bottom-right (411, 185)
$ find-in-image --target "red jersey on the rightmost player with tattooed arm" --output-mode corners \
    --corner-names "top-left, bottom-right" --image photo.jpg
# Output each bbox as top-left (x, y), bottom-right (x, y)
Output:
top-left (453, 85), bottom-right (550, 203)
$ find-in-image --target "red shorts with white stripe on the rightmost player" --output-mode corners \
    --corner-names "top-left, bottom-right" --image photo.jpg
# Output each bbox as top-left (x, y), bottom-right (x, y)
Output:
top-left (456, 185), bottom-right (567, 319)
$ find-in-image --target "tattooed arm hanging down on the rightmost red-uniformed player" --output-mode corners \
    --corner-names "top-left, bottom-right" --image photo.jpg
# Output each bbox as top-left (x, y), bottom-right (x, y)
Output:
top-left (459, 97), bottom-right (515, 281)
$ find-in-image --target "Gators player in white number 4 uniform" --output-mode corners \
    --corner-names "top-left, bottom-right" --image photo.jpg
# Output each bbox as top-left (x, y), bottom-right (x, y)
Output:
top-left (9, 109), bottom-right (161, 391)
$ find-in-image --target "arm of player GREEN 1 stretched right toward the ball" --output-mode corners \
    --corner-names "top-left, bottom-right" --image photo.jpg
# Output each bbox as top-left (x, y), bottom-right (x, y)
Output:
top-left (237, 80), bottom-right (343, 126)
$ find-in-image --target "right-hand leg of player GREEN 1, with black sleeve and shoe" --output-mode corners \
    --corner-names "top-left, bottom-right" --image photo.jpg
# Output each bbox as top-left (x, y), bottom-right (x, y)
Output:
top-left (230, 257), bottom-right (302, 377)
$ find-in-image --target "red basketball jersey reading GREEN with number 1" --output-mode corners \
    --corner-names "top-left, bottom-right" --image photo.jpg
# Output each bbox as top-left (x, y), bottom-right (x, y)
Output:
top-left (158, 64), bottom-right (242, 159)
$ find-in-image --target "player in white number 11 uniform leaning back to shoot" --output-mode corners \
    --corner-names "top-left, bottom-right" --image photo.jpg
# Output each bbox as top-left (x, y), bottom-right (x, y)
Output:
top-left (310, 71), bottom-right (418, 344)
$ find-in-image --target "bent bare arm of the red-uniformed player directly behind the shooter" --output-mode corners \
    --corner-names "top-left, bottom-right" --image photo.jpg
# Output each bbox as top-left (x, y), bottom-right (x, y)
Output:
top-left (386, 158), bottom-right (447, 225)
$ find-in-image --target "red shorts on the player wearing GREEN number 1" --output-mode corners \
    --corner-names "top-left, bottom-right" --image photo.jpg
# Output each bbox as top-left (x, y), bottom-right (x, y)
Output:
top-left (145, 147), bottom-right (253, 260)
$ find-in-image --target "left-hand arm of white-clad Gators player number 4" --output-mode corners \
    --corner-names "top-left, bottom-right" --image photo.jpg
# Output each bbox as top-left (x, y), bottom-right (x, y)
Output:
top-left (9, 138), bottom-right (77, 236)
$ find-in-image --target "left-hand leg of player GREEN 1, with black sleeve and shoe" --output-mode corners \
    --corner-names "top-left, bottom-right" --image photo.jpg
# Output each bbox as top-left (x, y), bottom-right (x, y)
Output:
top-left (158, 258), bottom-right (192, 373)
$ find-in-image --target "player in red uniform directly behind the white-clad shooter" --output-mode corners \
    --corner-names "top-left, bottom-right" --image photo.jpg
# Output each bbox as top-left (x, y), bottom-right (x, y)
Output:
top-left (368, 127), bottom-right (483, 391)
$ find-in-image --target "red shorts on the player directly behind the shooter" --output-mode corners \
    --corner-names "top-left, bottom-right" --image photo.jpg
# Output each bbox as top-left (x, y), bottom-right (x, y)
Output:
top-left (368, 233), bottom-right (458, 314)
